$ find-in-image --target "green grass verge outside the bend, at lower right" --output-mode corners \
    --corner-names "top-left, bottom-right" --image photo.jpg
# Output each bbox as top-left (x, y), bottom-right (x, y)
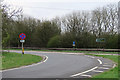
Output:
top-left (87, 54), bottom-right (120, 78)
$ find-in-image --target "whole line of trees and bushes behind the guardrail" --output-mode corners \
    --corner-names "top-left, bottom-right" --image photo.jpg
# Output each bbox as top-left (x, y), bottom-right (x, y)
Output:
top-left (1, 5), bottom-right (119, 48)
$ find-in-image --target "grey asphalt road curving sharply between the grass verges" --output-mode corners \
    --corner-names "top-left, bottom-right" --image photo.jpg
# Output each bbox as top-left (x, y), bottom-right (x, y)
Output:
top-left (2, 51), bottom-right (115, 78)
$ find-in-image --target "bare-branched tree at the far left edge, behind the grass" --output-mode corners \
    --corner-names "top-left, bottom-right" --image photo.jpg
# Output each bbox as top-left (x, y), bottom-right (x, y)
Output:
top-left (1, 4), bottom-right (22, 46)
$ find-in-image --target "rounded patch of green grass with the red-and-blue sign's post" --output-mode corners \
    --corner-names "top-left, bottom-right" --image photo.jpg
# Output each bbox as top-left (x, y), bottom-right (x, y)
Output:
top-left (2, 52), bottom-right (42, 70)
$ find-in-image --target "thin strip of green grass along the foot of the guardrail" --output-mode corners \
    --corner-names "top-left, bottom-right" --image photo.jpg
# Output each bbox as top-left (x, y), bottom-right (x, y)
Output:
top-left (3, 49), bottom-right (118, 54)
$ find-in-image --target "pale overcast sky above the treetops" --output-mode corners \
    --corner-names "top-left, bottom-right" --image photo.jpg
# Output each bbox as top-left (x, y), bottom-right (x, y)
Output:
top-left (2, 0), bottom-right (119, 20)
